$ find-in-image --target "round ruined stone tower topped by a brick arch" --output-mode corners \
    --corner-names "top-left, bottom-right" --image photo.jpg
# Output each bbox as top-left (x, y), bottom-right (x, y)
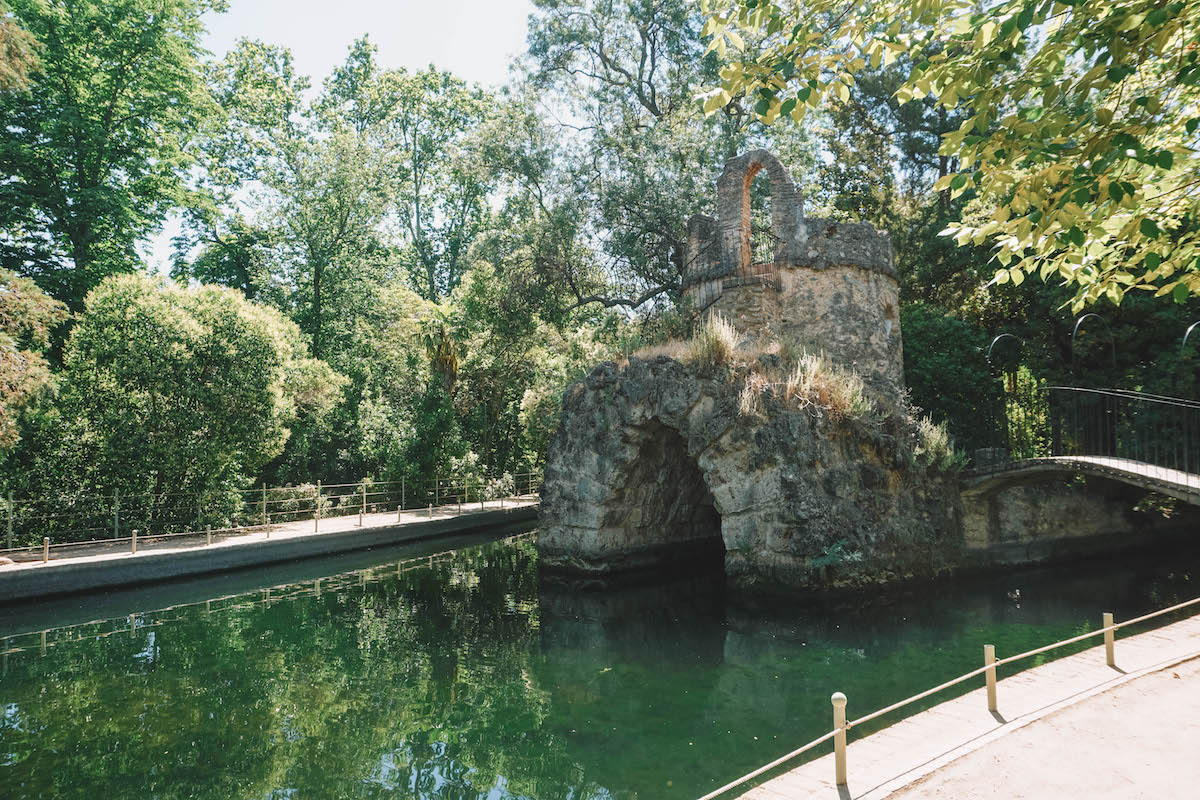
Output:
top-left (684, 150), bottom-right (904, 402)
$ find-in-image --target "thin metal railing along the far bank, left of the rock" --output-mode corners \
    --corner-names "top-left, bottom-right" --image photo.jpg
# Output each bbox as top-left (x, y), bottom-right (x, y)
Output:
top-left (0, 473), bottom-right (541, 561)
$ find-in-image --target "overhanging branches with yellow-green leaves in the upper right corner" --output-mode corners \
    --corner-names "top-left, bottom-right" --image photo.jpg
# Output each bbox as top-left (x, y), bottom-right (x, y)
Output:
top-left (704, 0), bottom-right (1200, 312)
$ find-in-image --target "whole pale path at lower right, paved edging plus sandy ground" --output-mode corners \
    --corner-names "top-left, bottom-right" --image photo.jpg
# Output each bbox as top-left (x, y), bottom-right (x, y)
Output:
top-left (743, 615), bottom-right (1200, 800)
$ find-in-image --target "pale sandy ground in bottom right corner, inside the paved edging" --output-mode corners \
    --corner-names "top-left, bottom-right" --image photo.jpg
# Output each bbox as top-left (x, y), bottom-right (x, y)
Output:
top-left (888, 658), bottom-right (1200, 800)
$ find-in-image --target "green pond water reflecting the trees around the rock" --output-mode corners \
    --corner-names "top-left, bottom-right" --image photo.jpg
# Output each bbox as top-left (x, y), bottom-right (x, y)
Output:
top-left (0, 536), bottom-right (1200, 800)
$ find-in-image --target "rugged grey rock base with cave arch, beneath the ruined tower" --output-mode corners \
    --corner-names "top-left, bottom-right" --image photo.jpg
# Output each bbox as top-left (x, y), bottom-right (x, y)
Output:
top-left (538, 357), bottom-right (961, 589)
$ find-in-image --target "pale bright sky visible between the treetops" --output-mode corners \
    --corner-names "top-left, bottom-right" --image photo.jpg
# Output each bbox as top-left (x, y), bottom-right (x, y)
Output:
top-left (146, 0), bottom-right (533, 272)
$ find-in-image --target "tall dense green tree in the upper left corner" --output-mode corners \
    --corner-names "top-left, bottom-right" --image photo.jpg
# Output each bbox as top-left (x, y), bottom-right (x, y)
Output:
top-left (0, 0), bottom-right (223, 311)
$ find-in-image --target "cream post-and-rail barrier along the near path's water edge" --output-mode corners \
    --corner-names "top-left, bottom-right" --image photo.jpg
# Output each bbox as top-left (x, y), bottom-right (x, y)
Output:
top-left (698, 597), bottom-right (1200, 800)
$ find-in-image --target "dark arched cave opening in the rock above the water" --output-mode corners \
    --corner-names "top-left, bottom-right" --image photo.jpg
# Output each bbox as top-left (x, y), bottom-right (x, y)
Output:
top-left (620, 419), bottom-right (725, 567)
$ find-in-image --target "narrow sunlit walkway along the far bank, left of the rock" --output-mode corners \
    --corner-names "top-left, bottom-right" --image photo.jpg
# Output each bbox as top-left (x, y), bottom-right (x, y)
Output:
top-left (0, 495), bottom-right (538, 572)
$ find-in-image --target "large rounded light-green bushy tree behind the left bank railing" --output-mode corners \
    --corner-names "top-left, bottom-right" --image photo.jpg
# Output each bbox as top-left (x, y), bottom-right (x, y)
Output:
top-left (36, 275), bottom-right (343, 497)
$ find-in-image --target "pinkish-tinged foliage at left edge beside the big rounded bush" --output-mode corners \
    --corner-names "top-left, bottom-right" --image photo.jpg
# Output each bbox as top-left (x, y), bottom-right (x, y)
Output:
top-left (0, 270), bottom-right (67, 453)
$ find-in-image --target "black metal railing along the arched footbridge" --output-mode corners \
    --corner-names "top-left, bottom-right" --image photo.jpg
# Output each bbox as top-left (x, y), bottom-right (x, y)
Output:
top-left (979, 386), bottom-right (1200, 473)
